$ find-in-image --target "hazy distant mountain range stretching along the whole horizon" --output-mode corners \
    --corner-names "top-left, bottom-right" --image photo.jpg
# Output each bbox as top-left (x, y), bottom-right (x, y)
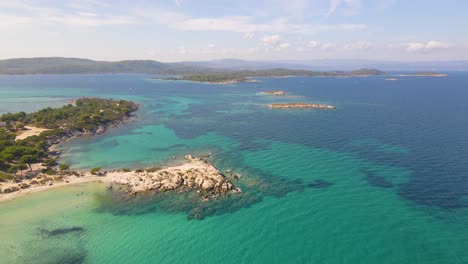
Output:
top-left (0, 57), bottom-right (468, 75)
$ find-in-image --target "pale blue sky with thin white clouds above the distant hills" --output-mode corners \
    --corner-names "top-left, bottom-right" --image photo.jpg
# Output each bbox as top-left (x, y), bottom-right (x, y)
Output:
top-left (0, 0), bottom-right (468, 62)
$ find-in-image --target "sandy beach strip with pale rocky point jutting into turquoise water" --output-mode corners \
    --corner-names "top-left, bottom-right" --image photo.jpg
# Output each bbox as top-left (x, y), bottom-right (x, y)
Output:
top-left (0, 155), bottom-right (242, 202)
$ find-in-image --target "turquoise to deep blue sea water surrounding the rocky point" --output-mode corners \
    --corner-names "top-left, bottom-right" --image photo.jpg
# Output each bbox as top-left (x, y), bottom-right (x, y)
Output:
top-left (0, 73), bottom-right (468, 263)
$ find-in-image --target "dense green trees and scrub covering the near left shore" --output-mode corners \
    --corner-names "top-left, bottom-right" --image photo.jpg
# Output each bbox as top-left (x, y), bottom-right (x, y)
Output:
top-left (0, 98), bottom-right (138, 176)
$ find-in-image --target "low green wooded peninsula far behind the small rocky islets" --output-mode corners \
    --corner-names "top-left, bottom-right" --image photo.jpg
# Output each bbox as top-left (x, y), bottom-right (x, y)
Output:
top-left (177, 69), bottom-right (385, 83)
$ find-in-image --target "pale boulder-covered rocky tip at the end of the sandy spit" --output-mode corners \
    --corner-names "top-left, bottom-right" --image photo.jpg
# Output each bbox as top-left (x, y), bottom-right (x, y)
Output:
top-left (108, 155), bottom-right (241, 198)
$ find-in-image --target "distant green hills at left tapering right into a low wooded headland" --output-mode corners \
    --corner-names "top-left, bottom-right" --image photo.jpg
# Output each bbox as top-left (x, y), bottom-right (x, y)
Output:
top-left (0, 57), bottom-right (386, 84)
